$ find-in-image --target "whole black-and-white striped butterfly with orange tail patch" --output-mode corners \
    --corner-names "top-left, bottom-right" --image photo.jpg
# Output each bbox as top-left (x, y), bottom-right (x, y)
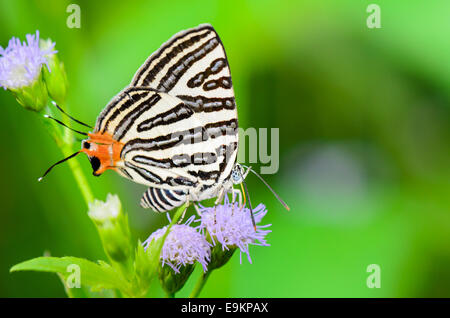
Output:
top-left (43, 24), bottom-right (287, 222)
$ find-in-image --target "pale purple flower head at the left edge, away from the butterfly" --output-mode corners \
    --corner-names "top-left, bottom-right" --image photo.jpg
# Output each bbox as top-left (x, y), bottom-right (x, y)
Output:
top-left (0, 31), bottom-right (57, 89)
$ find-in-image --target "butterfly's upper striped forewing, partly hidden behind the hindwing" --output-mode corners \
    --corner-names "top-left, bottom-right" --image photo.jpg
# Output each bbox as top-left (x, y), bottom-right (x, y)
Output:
top-left (131, 24), bottom-right (238, 191)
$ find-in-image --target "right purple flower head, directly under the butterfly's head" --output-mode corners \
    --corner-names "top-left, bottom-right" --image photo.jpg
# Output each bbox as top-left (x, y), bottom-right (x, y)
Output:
top-left (200, 197), bottom-right (272, 264)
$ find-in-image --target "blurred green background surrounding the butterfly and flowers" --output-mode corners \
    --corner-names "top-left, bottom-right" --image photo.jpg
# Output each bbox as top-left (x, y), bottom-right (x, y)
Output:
top-left (0, 0), bottom-right (450, 297)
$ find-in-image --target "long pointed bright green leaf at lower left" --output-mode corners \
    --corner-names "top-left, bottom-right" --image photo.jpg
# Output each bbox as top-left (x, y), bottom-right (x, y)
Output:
top-left (10, 257), bottom-right (130, 294)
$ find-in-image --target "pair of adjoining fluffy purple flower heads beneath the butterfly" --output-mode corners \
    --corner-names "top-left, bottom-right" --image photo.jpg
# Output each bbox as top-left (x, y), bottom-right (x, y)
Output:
top-left (144, 198), bottom-right (271, 272)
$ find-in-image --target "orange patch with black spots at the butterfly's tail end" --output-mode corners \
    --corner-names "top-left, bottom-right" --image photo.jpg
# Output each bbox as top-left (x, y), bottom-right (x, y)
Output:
top-left (81, 132), bottom-right (124, 176)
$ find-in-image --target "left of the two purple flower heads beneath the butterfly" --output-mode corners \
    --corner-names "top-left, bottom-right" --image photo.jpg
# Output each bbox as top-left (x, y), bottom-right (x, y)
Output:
top-left (143, 216), bottom-right (211, 273)
